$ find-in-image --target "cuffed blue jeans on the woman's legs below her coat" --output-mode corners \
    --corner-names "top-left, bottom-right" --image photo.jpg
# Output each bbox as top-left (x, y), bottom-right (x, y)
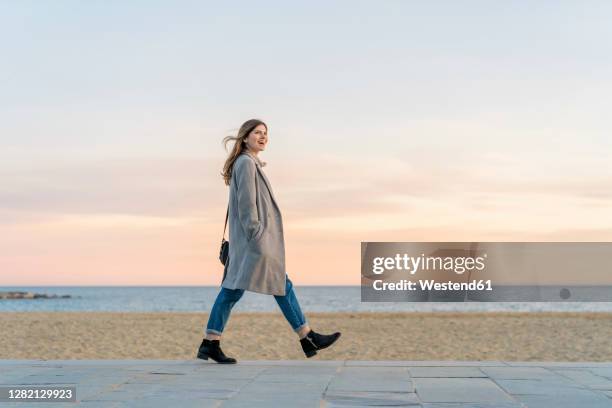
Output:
top-left (206, 276), bottom-right (308, 335)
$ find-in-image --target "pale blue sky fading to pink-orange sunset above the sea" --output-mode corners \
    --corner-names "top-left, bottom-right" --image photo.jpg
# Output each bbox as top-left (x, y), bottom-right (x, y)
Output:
top-left (0, 0), bottom-right (612, 286)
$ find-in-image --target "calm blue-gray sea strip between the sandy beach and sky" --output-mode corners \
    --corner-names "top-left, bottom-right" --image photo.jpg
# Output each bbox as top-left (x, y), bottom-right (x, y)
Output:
top-left (0, 285), bottom-right (612, 313)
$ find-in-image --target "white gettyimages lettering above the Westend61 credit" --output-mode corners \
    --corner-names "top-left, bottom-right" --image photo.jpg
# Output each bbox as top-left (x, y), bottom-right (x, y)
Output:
top-left (372, 254), bottom-right (487, 275)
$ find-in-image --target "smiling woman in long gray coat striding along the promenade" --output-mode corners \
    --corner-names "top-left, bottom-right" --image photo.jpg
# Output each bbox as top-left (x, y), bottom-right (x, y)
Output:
top-left (198, 119), bottom-right (340, 364)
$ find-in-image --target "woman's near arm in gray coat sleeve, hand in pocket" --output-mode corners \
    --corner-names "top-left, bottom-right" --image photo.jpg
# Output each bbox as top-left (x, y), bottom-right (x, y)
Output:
top-left (233, 158), bottom-right (263, 241)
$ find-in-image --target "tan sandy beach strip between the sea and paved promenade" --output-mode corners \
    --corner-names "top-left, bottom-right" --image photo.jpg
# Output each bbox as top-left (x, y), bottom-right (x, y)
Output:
top-left (0, 312), bottom-right (612, 361)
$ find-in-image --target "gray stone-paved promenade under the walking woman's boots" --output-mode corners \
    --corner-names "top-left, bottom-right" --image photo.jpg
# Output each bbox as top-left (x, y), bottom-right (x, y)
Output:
top-left (0, 360), bottom-right (612, 408)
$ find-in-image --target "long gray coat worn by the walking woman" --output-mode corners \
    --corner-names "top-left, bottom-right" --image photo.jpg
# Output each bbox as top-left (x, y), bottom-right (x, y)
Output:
top-left (221, 152), bottom-right (286, 296)
